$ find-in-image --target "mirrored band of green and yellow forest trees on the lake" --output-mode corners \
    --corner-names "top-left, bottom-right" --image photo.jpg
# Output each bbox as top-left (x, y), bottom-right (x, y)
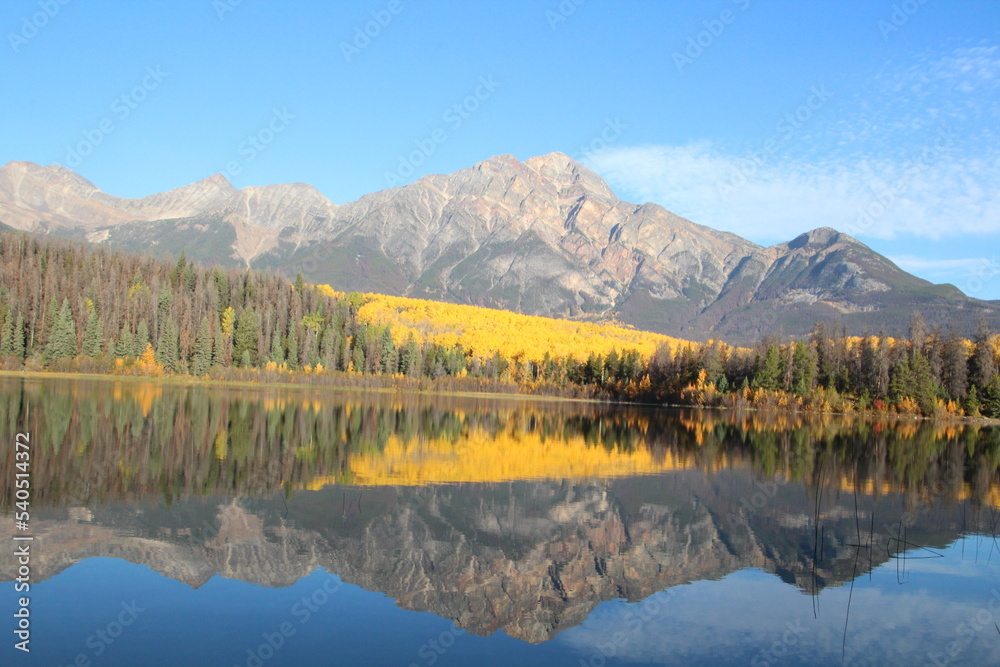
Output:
top-left (0, 382), bottom-right (1000, 512)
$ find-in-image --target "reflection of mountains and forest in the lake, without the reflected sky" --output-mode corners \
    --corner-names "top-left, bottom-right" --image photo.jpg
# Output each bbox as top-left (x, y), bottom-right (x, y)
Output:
top-left (0, 378), bottom-right (1000, 664)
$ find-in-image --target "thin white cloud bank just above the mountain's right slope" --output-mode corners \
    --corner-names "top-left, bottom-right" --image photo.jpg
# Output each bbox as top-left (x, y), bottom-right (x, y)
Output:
top-left (588, 139), bottom-right (1000, 241)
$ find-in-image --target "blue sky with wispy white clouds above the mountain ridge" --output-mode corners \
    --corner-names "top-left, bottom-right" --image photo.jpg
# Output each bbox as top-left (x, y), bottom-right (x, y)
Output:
top-left (0, 0), bottom-right (1000, 299)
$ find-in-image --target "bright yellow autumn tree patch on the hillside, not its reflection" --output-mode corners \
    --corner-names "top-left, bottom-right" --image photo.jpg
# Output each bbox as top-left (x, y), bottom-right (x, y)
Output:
top-left (317, 285), bottom-right (688, 362)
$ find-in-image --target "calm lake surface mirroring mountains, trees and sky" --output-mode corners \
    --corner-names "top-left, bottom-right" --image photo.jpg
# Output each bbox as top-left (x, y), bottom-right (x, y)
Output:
top-left (0, 376), bottom-right (1000, 667)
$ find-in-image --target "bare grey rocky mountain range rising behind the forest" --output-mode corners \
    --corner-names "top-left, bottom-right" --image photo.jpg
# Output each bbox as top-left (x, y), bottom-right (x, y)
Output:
top-left (0, 153), bottom-right (1000, 343)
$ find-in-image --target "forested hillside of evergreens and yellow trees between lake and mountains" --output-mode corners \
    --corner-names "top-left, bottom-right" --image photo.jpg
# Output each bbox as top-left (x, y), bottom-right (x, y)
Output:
top-left (0, 232), bottom-right (1000, 417)
